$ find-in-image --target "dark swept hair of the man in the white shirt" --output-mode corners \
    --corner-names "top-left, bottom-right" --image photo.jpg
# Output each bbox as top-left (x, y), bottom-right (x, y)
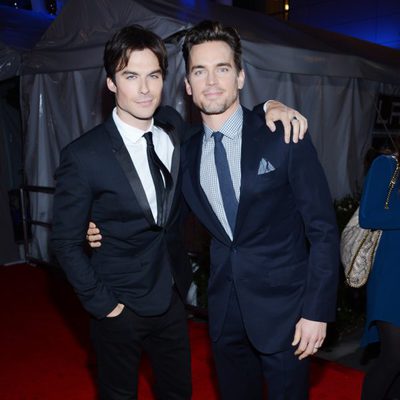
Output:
top-left (103, 25), bottom-right (168, 81)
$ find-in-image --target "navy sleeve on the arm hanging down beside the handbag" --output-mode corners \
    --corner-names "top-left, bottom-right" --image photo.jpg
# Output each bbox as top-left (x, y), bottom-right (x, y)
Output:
top-left (289, 135), bottom-right (339, 322)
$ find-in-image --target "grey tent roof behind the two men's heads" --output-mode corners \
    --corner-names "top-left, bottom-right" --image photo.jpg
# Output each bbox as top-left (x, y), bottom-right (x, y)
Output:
top-left (24, 0), bottom-right (400, 83)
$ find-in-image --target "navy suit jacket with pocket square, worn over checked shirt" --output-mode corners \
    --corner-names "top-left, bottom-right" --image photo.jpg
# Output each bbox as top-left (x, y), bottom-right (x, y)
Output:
top-left (182, 109), bottom-right (339, 353)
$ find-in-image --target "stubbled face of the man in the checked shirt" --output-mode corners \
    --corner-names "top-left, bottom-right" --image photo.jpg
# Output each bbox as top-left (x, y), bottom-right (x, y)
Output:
top-left (185, 41), bottom-right (244, 115)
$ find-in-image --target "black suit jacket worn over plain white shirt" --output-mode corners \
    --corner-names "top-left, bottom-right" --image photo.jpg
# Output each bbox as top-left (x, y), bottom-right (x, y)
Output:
top-left (51, 108), bottom-right (191, 318)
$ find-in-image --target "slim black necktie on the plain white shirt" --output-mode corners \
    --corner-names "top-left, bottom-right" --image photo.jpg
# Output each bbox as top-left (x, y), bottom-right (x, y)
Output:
top-left (143, 132), bottom-right (172, 226)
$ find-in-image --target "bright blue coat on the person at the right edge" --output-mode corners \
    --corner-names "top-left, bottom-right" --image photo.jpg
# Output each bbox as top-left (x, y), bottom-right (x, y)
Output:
top-left (360, 156), bottom-right (400, 345)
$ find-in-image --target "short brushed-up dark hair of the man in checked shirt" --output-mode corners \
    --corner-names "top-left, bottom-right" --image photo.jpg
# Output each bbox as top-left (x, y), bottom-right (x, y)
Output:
top-left (182, 20), bottom-right (243, 73)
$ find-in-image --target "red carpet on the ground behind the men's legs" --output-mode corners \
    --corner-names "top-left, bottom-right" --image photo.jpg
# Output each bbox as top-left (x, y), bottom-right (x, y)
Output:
top-left (0, 265), bottom-right (363, 400)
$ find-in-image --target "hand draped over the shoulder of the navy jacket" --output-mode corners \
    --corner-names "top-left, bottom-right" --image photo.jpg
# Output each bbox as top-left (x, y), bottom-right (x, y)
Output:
top-left (265, 100), bottom-right (308, 143)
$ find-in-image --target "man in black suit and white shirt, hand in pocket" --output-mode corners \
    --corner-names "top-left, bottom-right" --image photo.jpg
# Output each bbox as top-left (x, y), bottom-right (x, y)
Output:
top-left (52, 26), bottom-right (310, 400)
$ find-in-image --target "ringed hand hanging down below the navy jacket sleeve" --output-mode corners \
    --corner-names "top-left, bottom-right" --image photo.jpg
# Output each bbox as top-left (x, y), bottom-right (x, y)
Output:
top-left (292, 318), bottom-right (326, 360)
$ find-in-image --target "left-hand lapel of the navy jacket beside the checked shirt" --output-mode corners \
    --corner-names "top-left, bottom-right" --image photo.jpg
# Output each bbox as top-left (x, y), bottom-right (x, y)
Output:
top-left (186, 128), bottom-right (231, 242)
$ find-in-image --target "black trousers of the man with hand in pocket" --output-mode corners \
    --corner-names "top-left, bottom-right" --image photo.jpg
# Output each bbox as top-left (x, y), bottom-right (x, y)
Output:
top-left (91, 291), bottom-right (192, 400)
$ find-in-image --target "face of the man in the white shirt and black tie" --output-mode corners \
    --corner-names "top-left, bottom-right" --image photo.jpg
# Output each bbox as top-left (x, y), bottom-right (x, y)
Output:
top-left (107, 49), bottom-right (163, 129)
